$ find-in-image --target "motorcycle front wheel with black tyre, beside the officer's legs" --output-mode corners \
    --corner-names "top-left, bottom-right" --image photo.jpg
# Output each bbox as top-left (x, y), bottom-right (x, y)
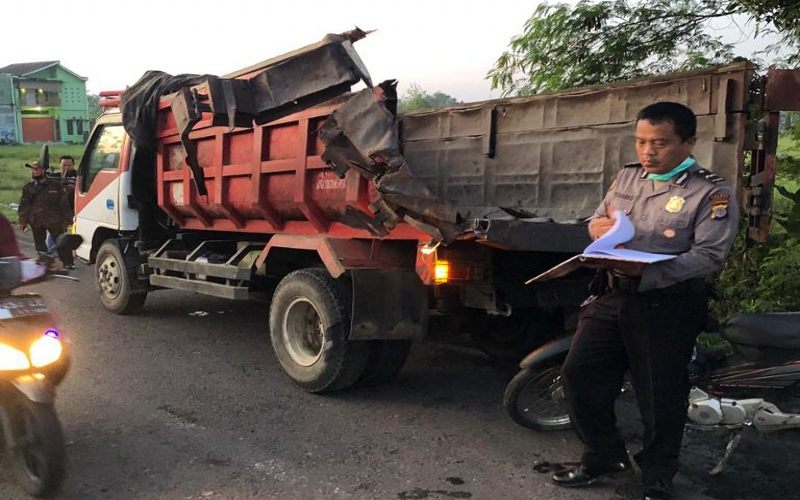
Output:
top-left (503, 359), bottom-right (572, 431)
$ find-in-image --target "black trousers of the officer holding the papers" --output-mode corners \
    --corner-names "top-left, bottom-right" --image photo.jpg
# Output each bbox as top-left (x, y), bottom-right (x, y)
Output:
top-left (562, 280), bottom-right (707, 482)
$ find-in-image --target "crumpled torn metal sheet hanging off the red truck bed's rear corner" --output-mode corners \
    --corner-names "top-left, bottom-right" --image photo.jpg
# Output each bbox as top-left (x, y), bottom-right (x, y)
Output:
top-left (319, 80), bottom-right (463, 243)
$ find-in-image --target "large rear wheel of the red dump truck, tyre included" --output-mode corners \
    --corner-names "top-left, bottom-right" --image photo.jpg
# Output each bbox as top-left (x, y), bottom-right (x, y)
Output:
top-left (269, 269), bottom-right (369, 393)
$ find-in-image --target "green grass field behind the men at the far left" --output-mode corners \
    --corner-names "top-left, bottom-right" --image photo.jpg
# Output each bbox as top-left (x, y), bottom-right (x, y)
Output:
top-left (0, 144), bottom-right (83, 222)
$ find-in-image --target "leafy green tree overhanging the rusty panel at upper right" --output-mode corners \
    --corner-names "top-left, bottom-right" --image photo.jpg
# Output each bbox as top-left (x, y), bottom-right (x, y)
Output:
top-left (487, 0), bottom-right (800, 95)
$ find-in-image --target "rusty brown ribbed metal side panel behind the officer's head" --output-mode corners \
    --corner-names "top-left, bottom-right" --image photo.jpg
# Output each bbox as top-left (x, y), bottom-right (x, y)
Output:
top-left (401, 64), bottom-right (752, 221)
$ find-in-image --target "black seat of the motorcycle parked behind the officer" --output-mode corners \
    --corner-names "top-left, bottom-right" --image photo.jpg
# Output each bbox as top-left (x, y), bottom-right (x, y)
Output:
top-left (722, 312), bottom-right (800, 349)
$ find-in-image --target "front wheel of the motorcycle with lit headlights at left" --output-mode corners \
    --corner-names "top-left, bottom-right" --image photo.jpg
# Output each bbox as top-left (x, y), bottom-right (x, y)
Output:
top-left (2, 395), bottom-right (66, 497)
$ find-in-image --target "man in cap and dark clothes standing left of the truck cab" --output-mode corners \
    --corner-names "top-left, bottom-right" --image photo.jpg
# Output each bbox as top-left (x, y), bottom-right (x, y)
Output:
top-left (19, 161), bottom-right (75, 269)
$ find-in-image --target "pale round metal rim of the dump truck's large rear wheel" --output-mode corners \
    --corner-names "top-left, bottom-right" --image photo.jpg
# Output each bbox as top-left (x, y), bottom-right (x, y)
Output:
top-left (283, 297), bottom-right (325, 366)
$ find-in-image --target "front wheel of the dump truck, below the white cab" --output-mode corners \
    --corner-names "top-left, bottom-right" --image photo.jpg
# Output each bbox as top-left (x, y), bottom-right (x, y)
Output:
top-left (94, 240), bottom-right (147, 314)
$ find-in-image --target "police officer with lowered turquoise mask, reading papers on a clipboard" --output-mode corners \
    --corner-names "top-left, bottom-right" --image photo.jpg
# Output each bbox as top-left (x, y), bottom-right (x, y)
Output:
top-left (553, 102), bottom-right (738, 499)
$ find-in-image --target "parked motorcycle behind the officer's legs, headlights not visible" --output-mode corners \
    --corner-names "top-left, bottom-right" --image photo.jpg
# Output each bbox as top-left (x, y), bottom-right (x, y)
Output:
top-left (503, 312), bottom-right (800, 474)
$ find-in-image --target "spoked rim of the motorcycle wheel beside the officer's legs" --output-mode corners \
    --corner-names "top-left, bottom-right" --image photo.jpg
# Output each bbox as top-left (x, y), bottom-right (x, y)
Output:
top-left (517, 367), bottom-right (570, 426)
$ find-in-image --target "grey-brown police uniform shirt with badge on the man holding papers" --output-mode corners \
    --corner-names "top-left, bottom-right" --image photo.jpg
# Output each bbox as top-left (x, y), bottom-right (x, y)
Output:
top-left (593, 163), bottom-right (739, 291)
